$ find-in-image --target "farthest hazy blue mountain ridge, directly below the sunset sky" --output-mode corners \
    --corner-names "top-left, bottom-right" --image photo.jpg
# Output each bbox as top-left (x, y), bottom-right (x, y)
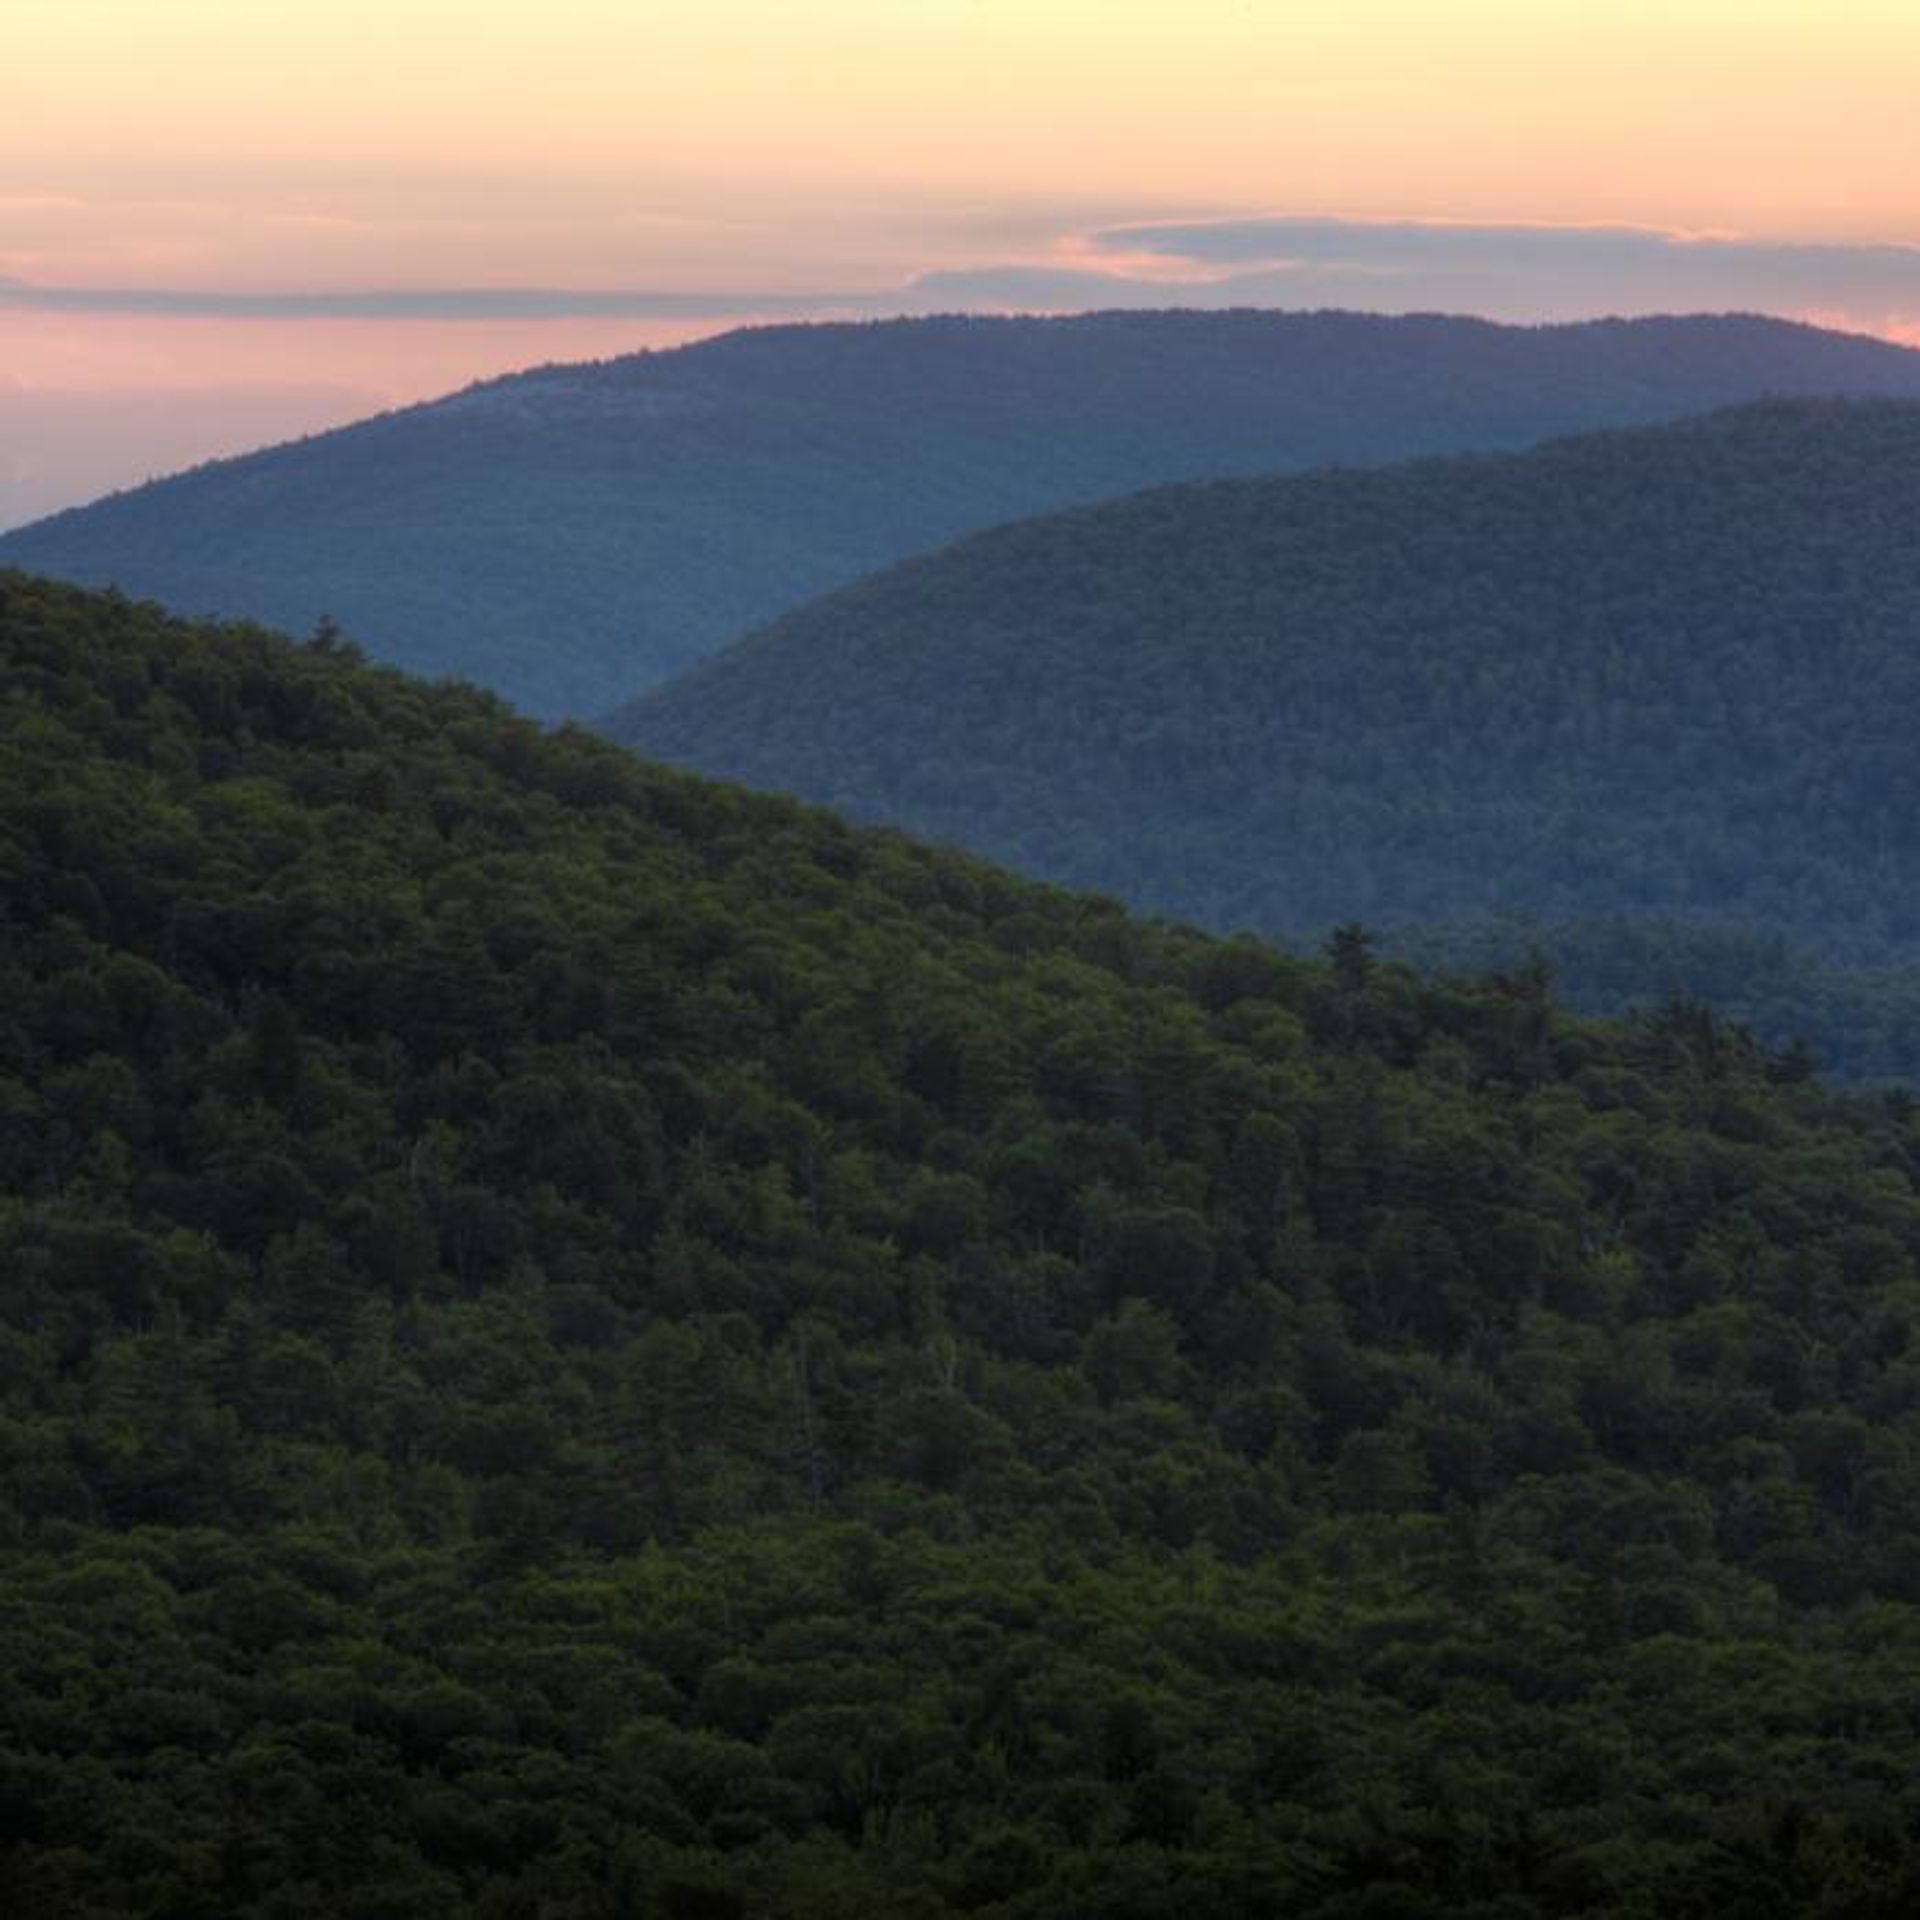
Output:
top-left (11, 311), bottom-right (1920, 718)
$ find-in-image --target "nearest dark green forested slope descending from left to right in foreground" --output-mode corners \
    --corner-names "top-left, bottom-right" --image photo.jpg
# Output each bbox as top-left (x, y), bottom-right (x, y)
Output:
top-left (15, 574), bottom-right (1920, 1920)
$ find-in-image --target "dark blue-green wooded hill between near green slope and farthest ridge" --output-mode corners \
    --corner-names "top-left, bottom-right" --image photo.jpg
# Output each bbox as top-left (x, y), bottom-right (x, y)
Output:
top-left (614, 401), bottom-right (1920, 1067)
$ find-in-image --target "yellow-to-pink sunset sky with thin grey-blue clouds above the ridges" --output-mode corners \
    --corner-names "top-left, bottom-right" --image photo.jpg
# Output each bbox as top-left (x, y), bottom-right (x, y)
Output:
top-left (0, 0), bottom-right (1920, 524)
